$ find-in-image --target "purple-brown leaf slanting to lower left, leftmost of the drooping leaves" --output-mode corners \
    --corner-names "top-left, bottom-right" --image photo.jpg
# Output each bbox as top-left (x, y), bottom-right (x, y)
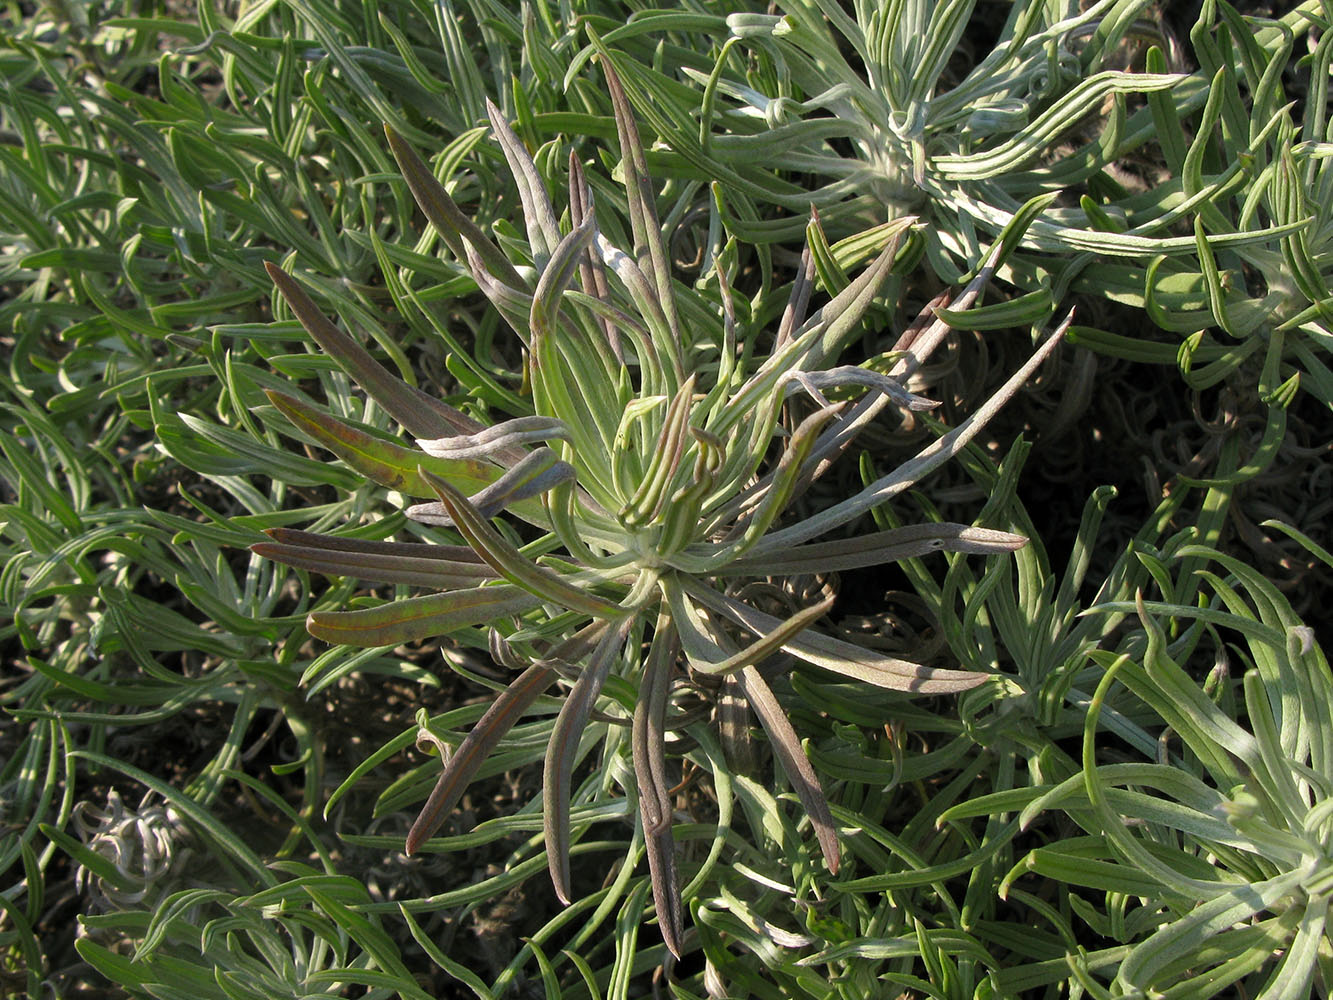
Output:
top-left (404, 621), bottom-right (607, 855)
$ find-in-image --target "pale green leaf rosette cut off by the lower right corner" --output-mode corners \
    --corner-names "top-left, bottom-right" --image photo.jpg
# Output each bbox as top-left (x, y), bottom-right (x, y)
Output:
top-left (970, 525), bottom-right (1333, 997)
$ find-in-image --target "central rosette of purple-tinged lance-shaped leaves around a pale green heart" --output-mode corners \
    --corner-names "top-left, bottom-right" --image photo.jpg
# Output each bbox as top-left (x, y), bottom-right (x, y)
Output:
top-left (247, 67), bottom-right (1068, 955)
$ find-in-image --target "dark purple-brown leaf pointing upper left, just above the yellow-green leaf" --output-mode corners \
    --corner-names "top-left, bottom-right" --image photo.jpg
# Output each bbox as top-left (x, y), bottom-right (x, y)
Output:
top-left (264, 261), bottom-right (481, 437)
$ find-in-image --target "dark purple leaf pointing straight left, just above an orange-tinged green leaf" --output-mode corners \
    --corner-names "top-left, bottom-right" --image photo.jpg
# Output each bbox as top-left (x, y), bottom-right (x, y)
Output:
top-left (251, 528), bottom-right (496, 591)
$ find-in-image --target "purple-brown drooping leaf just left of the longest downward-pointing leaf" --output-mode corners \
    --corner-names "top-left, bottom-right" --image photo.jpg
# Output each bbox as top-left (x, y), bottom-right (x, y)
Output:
top-left (541, 619), bottom-right (633, 907)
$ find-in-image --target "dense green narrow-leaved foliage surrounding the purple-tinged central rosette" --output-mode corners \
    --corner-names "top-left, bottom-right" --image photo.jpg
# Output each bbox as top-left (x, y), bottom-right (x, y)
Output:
top-left (0, 0), bottom-right (1333, 1000)
